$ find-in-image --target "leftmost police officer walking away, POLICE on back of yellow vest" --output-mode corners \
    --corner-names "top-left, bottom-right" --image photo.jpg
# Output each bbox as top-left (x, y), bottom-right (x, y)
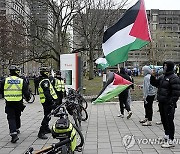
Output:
top-left (1, 65), bottom-right (30, 143)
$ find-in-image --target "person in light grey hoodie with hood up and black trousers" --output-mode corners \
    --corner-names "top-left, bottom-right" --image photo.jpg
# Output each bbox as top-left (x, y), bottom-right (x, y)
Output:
top-left (139, 66), bottom-right (156, 126)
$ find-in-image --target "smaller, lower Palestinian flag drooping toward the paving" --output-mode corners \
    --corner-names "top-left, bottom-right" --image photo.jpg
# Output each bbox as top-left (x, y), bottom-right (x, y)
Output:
top-left (92, 72), bottom-right (132, 104)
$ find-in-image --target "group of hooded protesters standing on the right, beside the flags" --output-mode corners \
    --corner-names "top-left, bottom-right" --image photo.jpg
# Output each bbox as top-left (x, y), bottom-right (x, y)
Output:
top-left (118, 61), bottom-right (180, 148)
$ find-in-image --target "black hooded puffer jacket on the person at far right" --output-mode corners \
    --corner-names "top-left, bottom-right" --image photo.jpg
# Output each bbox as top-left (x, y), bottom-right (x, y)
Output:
top-left (150, 61), bottom-right (180, 106)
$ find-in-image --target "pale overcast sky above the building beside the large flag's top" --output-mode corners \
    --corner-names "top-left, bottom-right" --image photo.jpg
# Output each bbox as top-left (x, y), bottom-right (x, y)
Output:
top-left (129, 0), bottom-right (180, 10)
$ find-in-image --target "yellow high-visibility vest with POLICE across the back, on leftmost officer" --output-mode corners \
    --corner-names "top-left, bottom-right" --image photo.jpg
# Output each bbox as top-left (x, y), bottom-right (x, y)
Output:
top-left (4, 76), bottom-right (23, 102)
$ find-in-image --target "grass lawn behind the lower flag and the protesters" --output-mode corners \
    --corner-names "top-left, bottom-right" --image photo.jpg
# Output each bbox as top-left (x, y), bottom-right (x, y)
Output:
top-left (83, 77), bottom-right (143, 101)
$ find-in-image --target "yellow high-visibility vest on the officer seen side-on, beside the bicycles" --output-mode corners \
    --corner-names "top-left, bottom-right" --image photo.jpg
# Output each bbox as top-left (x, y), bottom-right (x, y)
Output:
top-left (38, 79), bottom-right (57, 103)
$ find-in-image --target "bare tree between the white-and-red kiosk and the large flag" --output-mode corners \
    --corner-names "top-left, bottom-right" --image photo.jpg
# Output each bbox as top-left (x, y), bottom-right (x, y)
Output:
top-left (73, 0), bottom-right (128, 80)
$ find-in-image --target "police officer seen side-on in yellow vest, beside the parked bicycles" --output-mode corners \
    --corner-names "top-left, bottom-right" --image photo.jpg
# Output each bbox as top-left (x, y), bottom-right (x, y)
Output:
top-left (38, 67), bottom-right (57, 139)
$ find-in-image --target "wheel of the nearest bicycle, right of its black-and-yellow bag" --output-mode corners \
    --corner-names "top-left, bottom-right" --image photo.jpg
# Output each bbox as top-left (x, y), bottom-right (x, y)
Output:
top-left (72, 124), bottom-right (84, 148)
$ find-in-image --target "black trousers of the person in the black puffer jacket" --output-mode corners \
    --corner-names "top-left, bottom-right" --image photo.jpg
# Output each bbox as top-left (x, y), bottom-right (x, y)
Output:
top-left (159, 102), bottom-right (175, 140)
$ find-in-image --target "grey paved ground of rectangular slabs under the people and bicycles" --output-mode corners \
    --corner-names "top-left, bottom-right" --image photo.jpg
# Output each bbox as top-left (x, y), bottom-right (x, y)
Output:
top-left (0, 98), bottom-right (180, 154)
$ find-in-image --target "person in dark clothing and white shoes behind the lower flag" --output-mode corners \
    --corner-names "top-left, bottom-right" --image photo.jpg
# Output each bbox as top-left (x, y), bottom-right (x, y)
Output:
top-left (118, 67), bottom-right (133, 119)
